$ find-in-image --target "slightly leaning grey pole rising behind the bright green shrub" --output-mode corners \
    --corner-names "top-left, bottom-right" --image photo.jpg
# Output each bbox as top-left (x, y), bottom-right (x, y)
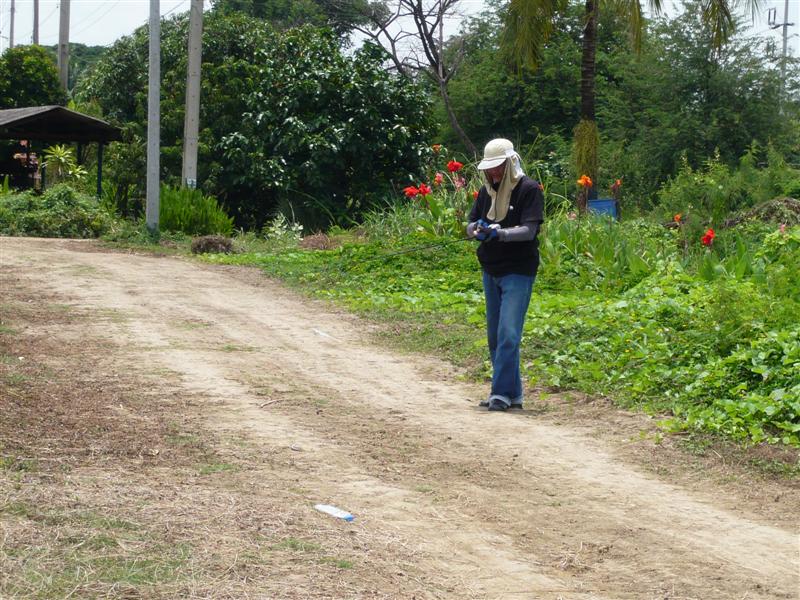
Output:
top-left (183, 0), bottom-right (203, 189)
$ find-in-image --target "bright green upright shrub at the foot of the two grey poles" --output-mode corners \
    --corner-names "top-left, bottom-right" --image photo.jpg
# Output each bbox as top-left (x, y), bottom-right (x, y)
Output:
top-left (159, 186), bottom-right (233, 235)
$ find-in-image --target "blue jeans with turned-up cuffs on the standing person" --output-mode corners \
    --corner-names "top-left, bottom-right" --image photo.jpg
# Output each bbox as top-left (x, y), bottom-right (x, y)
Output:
top-left (483, 271), bottom-right (535, 404)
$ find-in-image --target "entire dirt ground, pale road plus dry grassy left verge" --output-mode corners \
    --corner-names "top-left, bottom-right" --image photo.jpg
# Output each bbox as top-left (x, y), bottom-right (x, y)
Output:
top-left (0, 238), bottom-right (800, 600)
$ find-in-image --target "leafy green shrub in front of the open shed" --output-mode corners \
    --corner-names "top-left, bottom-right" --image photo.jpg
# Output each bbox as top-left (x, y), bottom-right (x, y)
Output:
top-left (0, 184), bottom-right (113, 238)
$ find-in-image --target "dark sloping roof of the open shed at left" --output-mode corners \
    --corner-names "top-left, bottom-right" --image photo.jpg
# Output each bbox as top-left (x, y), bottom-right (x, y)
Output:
top-left (0, 106), bottom-right (122, 142)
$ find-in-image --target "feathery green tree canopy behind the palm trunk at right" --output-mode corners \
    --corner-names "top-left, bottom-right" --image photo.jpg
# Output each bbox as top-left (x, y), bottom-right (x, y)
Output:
top-left (438, 2), bottom-right (798, 200)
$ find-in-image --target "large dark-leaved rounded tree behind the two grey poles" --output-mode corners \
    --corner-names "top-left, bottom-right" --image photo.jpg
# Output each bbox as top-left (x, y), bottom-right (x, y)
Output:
top-left (78, 11), bottom-right (430, 227)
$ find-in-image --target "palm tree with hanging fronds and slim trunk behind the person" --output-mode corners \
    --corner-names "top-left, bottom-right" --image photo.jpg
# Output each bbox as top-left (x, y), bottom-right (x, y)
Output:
top-left (503, 0), bottom-right (760, 209)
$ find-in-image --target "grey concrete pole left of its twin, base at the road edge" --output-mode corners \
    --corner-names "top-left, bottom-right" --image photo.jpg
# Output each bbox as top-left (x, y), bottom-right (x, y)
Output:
top-left (145, 0), bottom-right (161, 233)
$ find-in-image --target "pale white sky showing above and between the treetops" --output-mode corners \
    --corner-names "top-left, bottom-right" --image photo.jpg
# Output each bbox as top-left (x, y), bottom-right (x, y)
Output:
top-left (0, 0), bottom-right (800, 55)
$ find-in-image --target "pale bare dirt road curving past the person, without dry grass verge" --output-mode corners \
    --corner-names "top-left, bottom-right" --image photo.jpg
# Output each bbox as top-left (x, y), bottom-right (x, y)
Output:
top-left (0, 238), bottom-right (800, 600)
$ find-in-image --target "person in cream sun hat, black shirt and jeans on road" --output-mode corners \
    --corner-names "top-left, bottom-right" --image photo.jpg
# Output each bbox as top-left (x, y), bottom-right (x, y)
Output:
top-left (467, 138), bottom-right (544, 411)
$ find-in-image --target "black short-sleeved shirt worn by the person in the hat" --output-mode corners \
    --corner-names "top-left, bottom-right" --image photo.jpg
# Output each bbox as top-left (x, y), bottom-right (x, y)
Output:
top-left (469, 176), bottom-right (544, 277)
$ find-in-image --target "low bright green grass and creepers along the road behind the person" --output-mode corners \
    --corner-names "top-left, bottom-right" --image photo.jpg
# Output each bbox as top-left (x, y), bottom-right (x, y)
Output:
top-left (204, 219), bottom-right (800, 446)
